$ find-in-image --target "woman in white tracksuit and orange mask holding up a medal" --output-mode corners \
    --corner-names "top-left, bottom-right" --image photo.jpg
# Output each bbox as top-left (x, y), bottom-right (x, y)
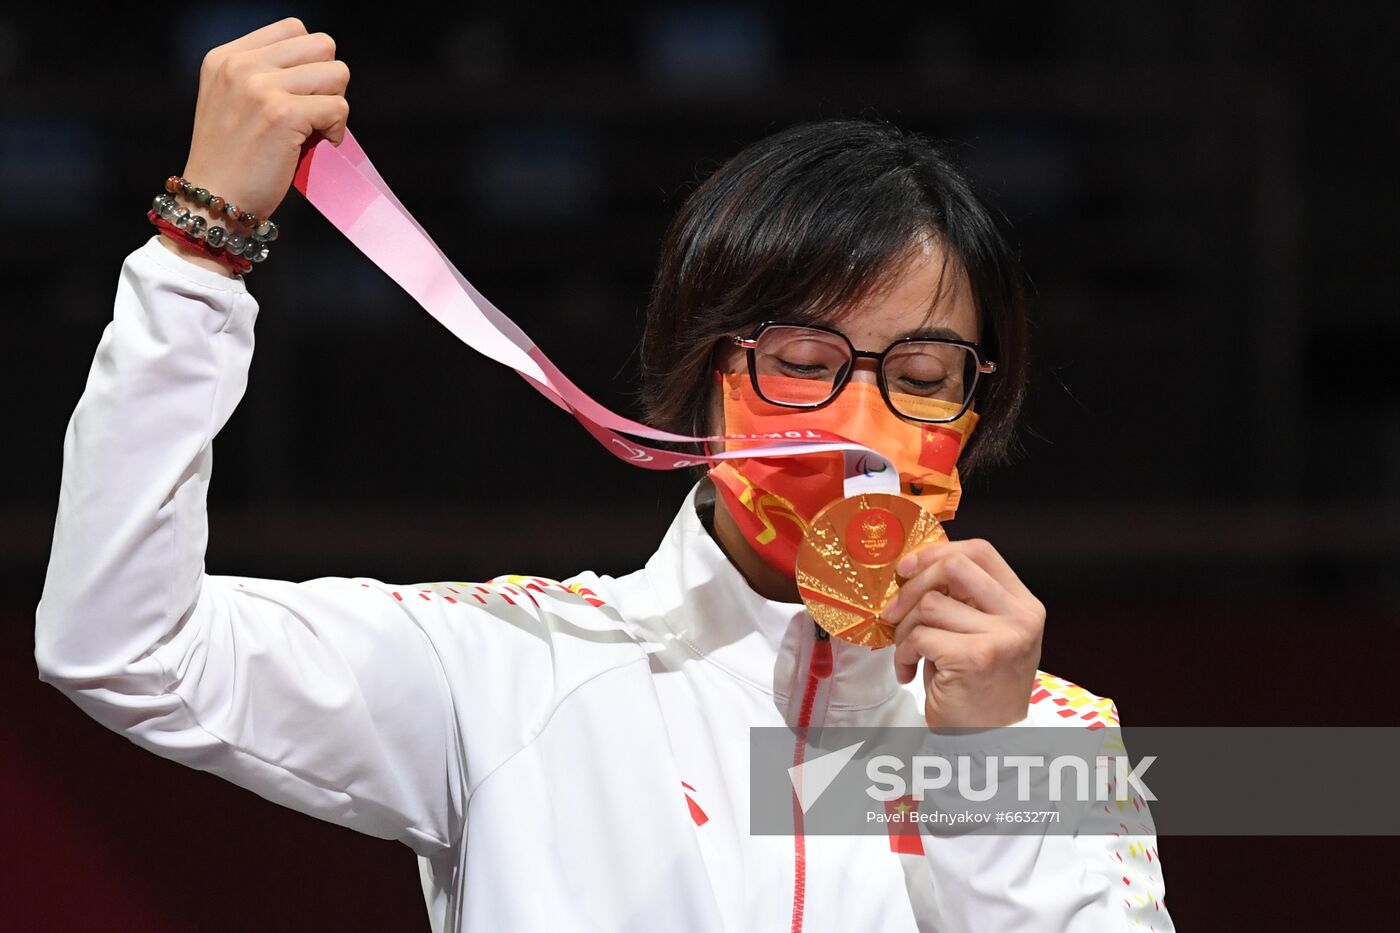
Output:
top-left (35, 18), bottom-right (1170, 930)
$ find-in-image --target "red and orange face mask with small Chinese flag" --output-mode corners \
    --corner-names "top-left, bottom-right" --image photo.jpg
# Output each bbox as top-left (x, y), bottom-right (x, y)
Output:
top-left (710, 370), bottom-right (977, 577)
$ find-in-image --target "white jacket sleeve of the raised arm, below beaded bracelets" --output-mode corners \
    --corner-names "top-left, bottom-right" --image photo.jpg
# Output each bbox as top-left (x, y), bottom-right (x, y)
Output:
top-left (35, 234), bottom-right (465, 855)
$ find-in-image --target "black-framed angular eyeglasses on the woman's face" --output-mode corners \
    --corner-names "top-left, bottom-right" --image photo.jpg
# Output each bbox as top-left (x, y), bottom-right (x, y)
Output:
top-left (729, 321), bottom-right (997, 423)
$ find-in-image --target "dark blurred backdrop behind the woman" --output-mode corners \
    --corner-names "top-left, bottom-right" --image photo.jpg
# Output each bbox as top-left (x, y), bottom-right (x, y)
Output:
top-left (0, 0), bottom-right (1400, 930)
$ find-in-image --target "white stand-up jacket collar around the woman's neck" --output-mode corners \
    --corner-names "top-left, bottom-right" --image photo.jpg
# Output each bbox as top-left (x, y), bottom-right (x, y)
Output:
top-left (633, 478), bottom-right (904, 709)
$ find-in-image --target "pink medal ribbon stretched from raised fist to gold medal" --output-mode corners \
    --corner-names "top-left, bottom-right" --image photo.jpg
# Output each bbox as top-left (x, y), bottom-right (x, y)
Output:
top-left (293, 129), bottom-right (899, 496)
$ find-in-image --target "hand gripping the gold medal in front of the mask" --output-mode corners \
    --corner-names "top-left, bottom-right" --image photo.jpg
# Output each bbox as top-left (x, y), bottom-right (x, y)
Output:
top-left (881, 538), bottom-right (1046, 728)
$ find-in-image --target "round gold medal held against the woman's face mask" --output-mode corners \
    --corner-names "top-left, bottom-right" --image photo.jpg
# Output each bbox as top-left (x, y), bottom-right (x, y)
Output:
top-left (797, 493), bottom-right (948, 649)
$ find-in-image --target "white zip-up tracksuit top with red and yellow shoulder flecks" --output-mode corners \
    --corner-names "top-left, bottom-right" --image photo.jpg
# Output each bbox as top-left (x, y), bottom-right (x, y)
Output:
top-left (35, 234), bottom-right (1172, 933)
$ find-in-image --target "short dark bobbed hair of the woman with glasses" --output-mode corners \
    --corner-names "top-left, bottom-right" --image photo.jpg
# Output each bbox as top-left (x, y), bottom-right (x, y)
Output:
top-left (638, 119), bottom-right (1029, 476)
